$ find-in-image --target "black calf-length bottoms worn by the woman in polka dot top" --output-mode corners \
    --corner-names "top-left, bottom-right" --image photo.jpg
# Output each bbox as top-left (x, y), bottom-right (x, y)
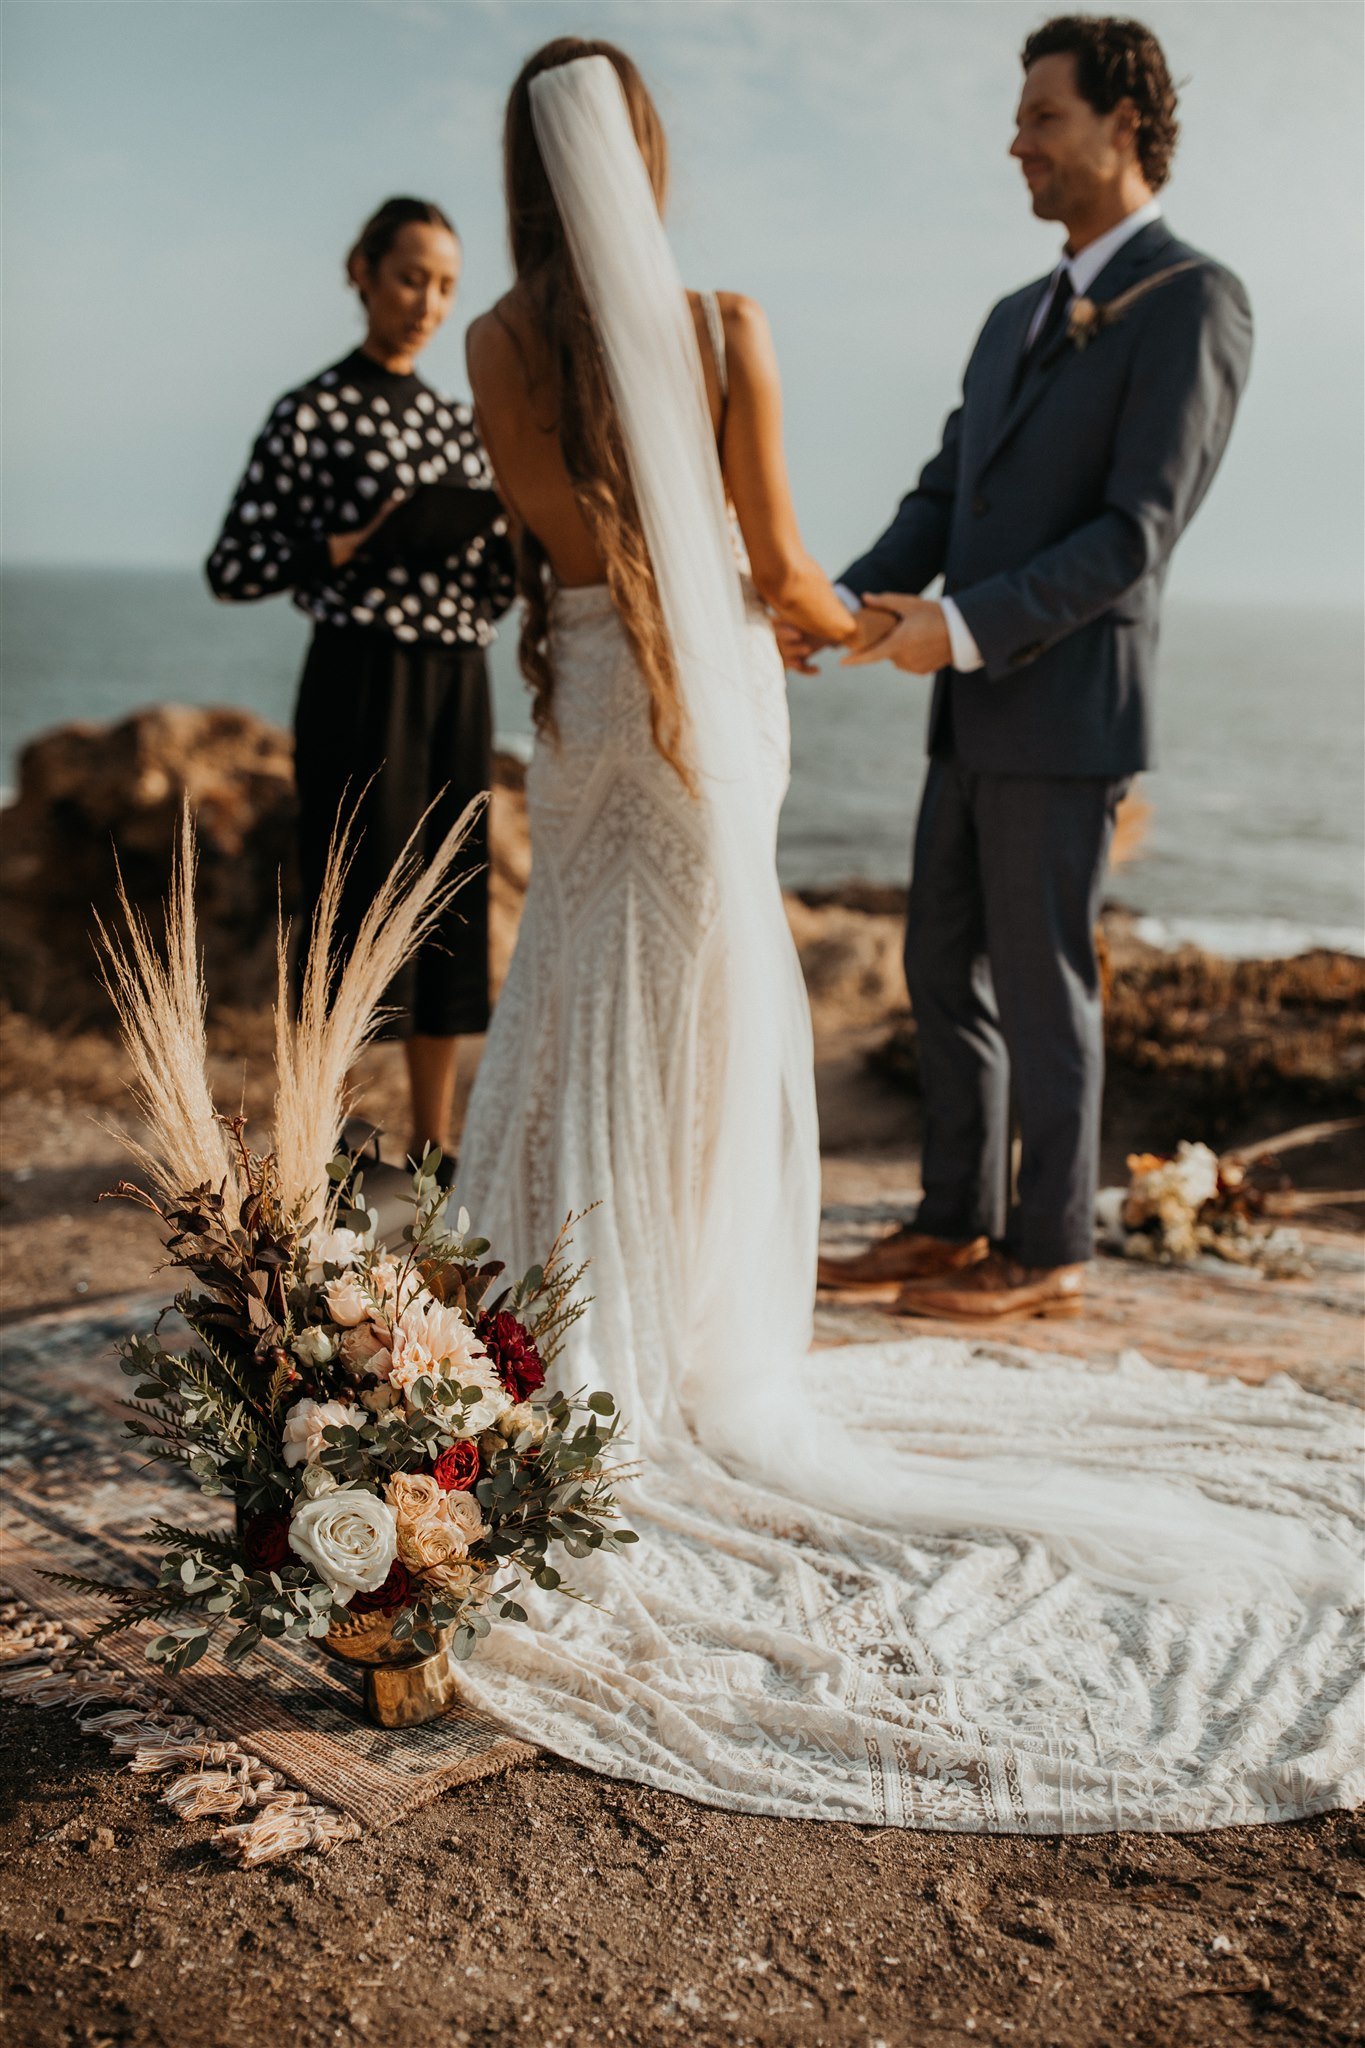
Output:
top-left (295, 627), bottom-right (491, 1038)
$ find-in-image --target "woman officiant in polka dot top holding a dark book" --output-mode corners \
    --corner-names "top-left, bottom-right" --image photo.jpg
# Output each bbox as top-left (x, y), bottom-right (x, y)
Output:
top-left (207, 199), bottom-right (514, 1187)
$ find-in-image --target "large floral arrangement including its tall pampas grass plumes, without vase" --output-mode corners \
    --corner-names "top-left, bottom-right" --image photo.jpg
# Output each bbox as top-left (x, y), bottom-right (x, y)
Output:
top-left (63, 805), bottom-right (634, 1671)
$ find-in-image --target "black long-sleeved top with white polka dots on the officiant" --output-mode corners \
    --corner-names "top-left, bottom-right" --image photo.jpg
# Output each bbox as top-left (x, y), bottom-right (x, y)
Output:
top-left (205, 348), bottom-right (516, 647)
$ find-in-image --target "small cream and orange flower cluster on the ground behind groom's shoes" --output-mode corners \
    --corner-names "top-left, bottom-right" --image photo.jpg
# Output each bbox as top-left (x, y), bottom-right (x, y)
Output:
top-left (1099, 1141), bottom-right (1310, 1278)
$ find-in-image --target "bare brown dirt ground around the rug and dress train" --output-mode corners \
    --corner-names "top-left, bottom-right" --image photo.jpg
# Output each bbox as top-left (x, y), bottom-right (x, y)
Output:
top-left (0, 999), bottom-right (1365, 2048)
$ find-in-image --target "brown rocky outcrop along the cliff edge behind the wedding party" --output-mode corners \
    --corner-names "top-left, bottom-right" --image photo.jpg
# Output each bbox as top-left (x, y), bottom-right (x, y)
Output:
top-left (0, 707), bottom-right (1365, 1145)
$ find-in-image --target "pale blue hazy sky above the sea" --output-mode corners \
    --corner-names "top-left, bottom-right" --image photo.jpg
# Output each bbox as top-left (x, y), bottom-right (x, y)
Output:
top-left (2, 0), bottom-right (1365, 604)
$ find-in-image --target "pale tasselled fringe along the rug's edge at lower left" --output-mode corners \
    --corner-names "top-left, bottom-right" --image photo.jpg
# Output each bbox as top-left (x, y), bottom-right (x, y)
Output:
top-left (0, 1602), bottom-right (360, 1866)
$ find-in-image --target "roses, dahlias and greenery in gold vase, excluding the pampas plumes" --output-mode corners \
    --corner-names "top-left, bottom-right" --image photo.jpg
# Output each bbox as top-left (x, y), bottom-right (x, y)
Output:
top-left (65, 1146), bottom-right (634, 1671)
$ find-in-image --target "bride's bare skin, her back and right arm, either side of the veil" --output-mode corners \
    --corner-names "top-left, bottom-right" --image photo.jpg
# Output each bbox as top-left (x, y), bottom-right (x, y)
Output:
top-left (467, 287), bottom-right (853, 643)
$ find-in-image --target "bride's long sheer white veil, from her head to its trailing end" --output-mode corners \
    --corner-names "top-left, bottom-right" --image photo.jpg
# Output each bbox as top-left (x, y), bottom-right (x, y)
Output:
top-left (519, 57), bottom-right (1342, 1595)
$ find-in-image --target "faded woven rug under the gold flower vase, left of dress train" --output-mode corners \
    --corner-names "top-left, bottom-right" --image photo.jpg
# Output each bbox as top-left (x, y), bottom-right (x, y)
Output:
top-left (0, 1296), bottom-right (536, 1827)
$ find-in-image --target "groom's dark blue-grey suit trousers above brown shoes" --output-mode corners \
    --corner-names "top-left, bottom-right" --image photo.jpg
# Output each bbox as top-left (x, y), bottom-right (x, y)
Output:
top-left (905, 754), bottom-right (1130, 1266)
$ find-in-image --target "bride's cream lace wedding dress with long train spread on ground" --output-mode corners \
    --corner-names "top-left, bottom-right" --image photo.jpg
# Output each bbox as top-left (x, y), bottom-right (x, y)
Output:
top-left (458, 590), bottom-right (1361, 1833)
